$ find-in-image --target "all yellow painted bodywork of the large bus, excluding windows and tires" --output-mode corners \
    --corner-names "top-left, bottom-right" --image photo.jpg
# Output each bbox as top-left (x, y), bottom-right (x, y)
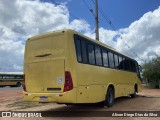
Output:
top-left (23, 30), bottom-right (141, 103)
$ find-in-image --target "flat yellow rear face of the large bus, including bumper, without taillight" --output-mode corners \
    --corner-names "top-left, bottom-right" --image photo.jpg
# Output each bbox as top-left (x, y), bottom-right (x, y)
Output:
top-left (23, 32), bottom-right (76, 103)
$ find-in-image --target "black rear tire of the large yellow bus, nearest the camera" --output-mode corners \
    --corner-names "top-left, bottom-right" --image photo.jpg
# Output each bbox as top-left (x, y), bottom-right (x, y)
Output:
top-left (104, 87), bottom-right (114, 107)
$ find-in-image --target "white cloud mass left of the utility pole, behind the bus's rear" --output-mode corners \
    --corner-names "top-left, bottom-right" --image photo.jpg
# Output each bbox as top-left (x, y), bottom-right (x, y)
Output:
top-left (0, 0), bottom-right (90, 72)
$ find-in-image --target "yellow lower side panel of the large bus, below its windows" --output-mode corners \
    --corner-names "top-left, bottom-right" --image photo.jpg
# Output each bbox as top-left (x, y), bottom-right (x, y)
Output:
top-left (77, 63), bottom-right (138, 103)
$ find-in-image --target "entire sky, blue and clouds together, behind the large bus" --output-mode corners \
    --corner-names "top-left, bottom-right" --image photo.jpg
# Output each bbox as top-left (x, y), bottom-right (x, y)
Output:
top-left (0, 0), bottom-right (160, 72)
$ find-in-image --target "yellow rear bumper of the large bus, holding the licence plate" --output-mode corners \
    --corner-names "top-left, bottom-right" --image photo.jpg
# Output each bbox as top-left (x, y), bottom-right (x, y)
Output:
top-left (23, 90), bottom-right (76, 103)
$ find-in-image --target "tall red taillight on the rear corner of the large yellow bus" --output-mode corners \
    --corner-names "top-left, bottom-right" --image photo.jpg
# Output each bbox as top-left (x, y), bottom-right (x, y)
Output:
top-left (63, 71), bottom-right (73, 92)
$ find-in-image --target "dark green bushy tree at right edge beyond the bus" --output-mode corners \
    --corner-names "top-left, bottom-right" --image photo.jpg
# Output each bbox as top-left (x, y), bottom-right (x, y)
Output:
top-left (142, 56), bottom-right (160, 83)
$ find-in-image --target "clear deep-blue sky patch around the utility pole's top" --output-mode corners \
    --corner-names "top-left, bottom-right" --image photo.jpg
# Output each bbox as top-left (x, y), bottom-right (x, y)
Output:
top-left (65, 0), bottom-right (160, 29)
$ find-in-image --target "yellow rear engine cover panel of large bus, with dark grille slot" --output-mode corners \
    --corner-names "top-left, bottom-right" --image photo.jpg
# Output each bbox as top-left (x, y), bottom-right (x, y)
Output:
top-left (25, 60), bottom-right (64, 93)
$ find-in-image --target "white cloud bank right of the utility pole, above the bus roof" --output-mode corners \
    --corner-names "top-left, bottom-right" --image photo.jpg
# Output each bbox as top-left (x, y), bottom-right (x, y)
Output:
top-left (74, 7), bottom-right (160, 64)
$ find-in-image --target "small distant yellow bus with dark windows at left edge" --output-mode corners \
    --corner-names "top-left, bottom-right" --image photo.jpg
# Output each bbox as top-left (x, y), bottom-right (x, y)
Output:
top-left (0, 73), bottom-right (23, 87)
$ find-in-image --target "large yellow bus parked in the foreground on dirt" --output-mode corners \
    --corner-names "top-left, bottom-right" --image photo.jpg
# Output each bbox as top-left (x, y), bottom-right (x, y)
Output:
top-left (23, 30), bottom-right (141, 107)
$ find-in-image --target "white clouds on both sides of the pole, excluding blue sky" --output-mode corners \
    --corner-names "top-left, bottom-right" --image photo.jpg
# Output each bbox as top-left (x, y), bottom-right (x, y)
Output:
top-left (0, 0), bottom-right (160, 72)
